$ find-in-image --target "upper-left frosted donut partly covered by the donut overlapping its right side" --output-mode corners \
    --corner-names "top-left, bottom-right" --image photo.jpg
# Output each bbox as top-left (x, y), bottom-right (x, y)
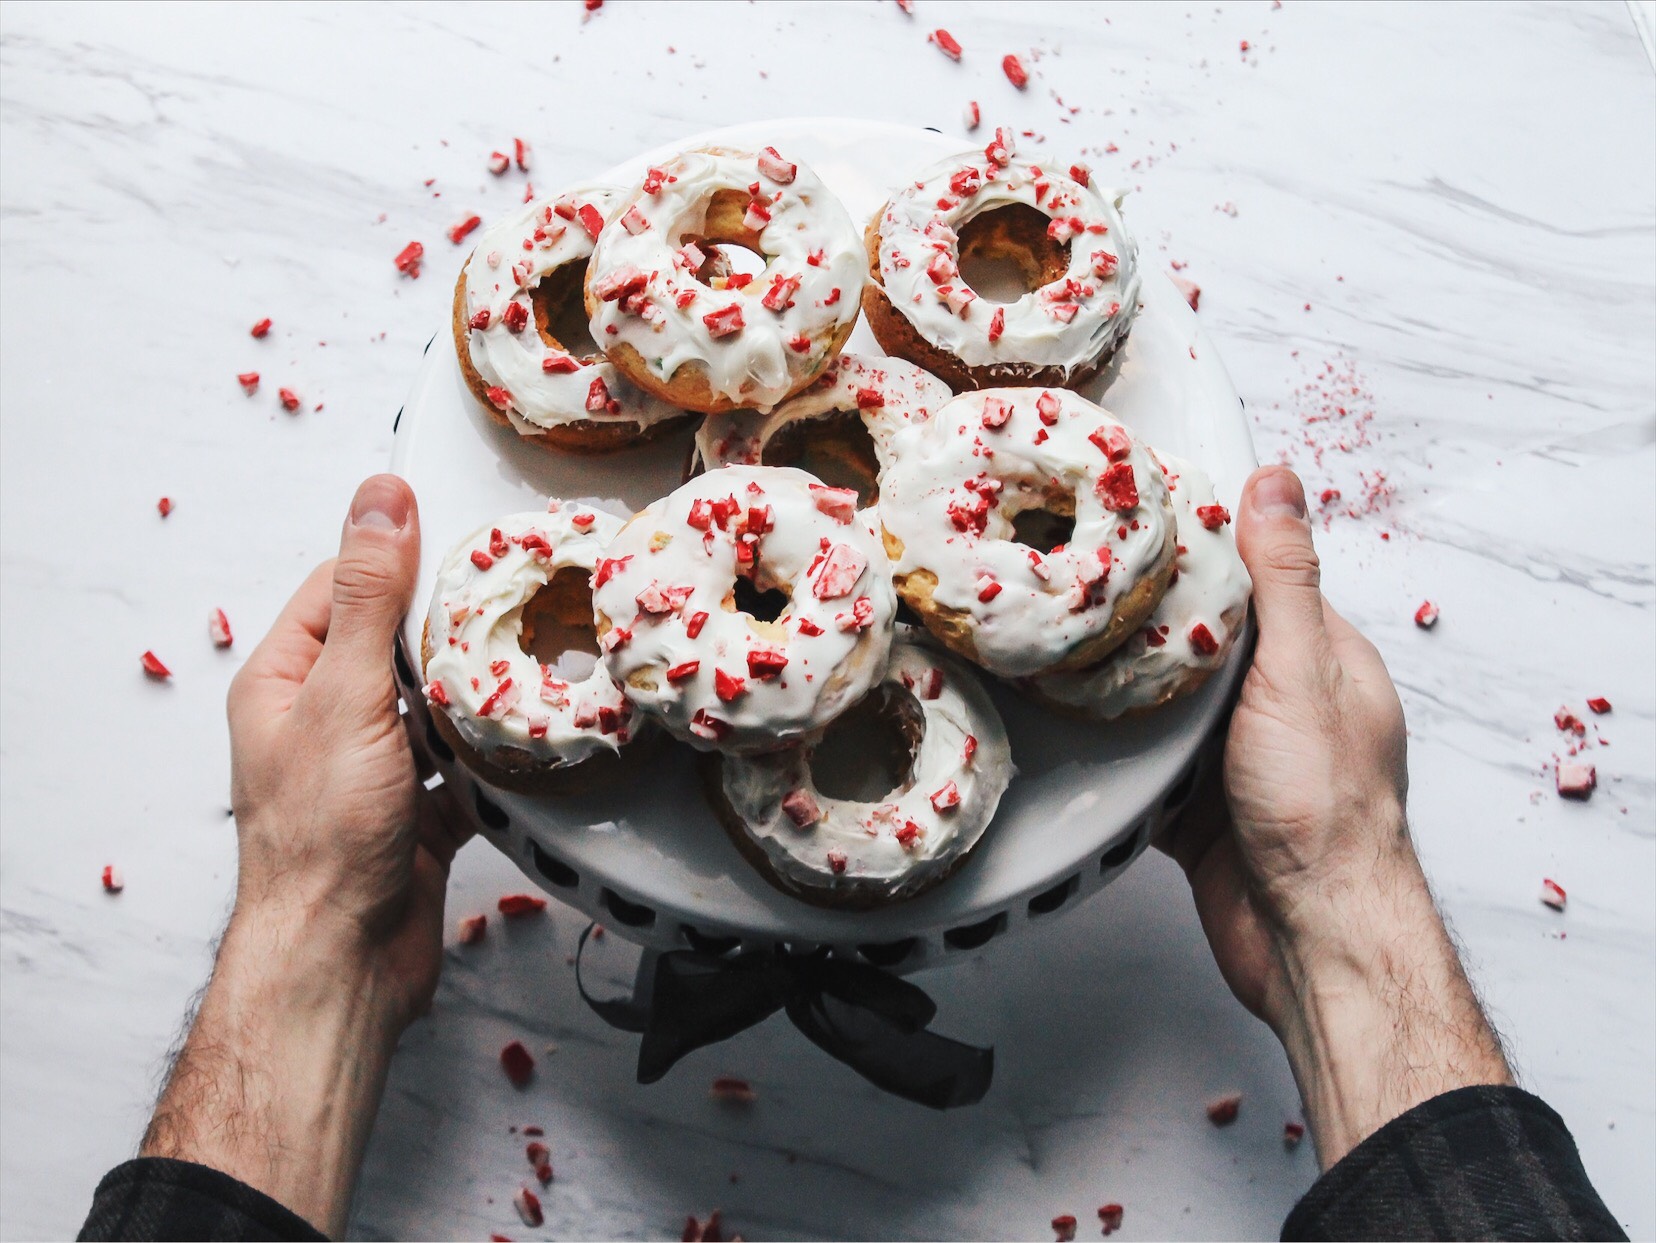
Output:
top-left (454, 185), bottom-right (684, 454)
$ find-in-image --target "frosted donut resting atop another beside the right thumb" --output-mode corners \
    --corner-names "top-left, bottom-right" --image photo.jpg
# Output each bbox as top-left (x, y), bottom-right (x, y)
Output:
top-left (879, 389), bottom-right (1176, 677)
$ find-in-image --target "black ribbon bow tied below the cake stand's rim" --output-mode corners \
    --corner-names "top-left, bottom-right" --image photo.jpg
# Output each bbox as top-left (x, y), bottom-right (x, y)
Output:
top-left (575, 927), bottom-right (995, 1109)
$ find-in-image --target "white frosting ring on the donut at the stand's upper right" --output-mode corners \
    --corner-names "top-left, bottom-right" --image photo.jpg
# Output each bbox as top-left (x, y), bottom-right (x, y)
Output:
top-left (879, 139), bottom-right (1139, 372)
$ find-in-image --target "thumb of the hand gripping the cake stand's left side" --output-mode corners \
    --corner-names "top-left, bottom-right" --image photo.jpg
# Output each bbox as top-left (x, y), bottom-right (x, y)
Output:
top-left (318, 475), bottom-right (419, 680)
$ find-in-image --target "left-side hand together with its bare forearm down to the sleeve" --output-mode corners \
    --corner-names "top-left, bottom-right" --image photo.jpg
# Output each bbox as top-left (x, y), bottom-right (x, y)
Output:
top-left (139, 475), bottom-right (465, 1235)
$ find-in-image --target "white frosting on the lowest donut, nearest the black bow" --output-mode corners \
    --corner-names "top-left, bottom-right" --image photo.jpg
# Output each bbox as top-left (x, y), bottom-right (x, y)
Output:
top-left (720, 641), bottom-right (1013, 897)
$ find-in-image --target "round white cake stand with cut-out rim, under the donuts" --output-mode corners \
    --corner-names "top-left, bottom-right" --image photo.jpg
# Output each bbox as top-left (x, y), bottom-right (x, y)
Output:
top-left (391, 118), bottom-right (1255, 973)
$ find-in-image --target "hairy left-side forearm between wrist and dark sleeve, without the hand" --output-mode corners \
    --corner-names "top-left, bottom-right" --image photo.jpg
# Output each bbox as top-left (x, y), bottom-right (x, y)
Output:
top-left (139, 910), bottom-right (396, 1235)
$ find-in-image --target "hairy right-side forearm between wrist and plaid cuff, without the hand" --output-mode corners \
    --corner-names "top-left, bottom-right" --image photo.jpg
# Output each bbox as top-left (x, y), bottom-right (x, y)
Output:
top-left (1272, 837), bottom-right (1512, 1169)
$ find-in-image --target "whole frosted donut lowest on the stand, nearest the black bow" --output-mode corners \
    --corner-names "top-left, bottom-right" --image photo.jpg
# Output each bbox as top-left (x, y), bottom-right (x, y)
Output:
top-left (705, 641), bottom-right (1013, 907)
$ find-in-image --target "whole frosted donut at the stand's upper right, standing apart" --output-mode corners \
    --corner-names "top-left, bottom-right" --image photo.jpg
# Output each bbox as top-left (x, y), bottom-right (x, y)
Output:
top-left (863, 129), bottom-right (1139, 392)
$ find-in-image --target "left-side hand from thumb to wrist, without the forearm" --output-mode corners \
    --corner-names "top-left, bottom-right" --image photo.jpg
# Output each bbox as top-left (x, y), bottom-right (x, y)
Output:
top-left (229, 475), bottom-right (465, 1029)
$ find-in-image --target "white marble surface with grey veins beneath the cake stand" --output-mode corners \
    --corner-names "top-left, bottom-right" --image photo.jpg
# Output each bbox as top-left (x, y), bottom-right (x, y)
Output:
top-left (0, 0), bottom-right (1656, 1238)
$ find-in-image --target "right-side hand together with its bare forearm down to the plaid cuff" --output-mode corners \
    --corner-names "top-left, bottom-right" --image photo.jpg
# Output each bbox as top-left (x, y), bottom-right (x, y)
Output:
top-left (1158, 467), bottom-right (1510, 1164)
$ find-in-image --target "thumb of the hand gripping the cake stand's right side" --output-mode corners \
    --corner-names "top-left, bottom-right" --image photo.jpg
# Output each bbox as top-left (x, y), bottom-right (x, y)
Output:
top-left (1237, 467), bottom-right (1328, 650)
